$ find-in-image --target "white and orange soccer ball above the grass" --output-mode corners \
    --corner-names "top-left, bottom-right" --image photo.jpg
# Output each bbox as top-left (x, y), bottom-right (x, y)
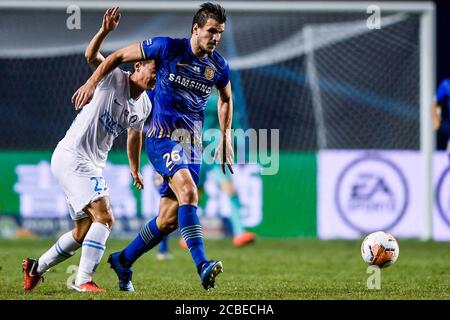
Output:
top-left (361, 231), bottom-right (400, 268)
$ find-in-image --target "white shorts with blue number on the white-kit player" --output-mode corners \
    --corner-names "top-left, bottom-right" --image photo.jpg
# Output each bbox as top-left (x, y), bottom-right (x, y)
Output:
top-left (51, 147), bottom-right (109, 220)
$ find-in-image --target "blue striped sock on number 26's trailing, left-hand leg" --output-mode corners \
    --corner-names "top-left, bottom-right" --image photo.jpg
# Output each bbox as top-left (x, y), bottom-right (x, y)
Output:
top-left (120, 218), bottom-right (167, 267)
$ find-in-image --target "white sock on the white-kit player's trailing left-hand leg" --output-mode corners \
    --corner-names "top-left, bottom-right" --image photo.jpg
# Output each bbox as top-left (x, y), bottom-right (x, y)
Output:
top-left (37, 231), bottom-right (81, 274)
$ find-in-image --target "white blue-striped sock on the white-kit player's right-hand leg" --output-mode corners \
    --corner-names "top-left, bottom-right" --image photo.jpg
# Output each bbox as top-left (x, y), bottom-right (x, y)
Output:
top-left (75, 222), bottom-right (111, 286)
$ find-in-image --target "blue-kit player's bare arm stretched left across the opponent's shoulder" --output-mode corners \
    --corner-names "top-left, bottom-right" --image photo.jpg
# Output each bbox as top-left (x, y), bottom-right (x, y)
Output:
top-left (72, 43), bottom-right (145, 110)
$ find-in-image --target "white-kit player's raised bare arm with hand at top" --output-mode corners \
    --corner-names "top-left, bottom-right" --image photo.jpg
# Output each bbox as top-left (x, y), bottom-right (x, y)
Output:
top-left (84, 7), bottom-right (120, 70)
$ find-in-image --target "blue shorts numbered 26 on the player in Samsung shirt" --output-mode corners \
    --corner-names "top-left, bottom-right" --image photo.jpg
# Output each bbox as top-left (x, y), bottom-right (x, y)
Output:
top-left (145, 137), bottom-right (201, 197)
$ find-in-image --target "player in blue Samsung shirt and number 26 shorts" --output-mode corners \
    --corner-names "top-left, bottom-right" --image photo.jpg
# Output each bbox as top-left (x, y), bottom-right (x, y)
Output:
top-left (72, 3), bottom-right (234, 291)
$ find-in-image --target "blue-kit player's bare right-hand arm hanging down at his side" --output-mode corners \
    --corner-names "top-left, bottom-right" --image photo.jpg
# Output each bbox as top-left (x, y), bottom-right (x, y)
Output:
top-left (214, 82), bottom-right (234, 174)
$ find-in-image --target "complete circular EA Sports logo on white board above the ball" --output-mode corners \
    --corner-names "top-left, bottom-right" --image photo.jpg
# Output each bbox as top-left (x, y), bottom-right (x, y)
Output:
top-left (335, 156), bottom-right (409, 233)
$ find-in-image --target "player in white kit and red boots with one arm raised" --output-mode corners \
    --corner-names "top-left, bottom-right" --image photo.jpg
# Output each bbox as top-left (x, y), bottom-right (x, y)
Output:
top-left (23, 7), bottom-right (156, 292)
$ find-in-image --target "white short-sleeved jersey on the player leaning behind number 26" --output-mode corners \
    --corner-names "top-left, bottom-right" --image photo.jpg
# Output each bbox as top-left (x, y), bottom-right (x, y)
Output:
top-left (58, 68), bottom-right (152, 176)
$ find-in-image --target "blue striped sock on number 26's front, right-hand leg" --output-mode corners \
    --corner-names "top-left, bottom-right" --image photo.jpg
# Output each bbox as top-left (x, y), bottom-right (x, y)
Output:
top-left (178, 204), bottom-right (207, 271)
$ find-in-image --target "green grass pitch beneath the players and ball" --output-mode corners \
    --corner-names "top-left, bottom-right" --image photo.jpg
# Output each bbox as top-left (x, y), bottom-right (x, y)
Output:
top-left (0, 238), bottom-right (450, 300)
